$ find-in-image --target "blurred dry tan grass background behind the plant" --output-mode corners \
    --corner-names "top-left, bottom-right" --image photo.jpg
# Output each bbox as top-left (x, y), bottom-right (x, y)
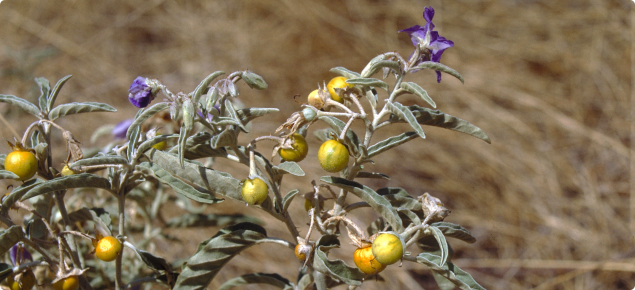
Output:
top-left (0, 0), bottom-right (635, 289)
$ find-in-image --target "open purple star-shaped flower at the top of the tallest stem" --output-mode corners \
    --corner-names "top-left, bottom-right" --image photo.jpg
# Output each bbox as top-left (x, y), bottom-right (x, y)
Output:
top-left (399, 7), bottom-right (454, 83)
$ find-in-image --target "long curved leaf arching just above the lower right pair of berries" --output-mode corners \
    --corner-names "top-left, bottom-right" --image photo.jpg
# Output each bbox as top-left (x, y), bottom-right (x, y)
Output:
top-left (320, 176), bottom-right (403, 232)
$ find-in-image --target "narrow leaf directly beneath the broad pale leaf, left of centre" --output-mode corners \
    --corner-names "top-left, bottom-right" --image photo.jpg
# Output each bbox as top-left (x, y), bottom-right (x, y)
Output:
top-left (140, 162), bottom-right (223, 204)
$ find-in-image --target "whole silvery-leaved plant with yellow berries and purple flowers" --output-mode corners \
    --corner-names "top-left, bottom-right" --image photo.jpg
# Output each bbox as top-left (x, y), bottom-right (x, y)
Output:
top-left (0, 7), bottom-right (490, 290)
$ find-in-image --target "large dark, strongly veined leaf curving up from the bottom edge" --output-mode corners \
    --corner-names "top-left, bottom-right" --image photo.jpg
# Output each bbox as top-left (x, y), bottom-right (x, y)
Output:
top-left (173, 223), bottom-right (267, 290)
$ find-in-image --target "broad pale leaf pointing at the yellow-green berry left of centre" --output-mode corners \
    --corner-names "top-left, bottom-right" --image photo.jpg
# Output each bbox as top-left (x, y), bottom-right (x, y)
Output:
top-left (146, 149), bottom-right (243, 201)
